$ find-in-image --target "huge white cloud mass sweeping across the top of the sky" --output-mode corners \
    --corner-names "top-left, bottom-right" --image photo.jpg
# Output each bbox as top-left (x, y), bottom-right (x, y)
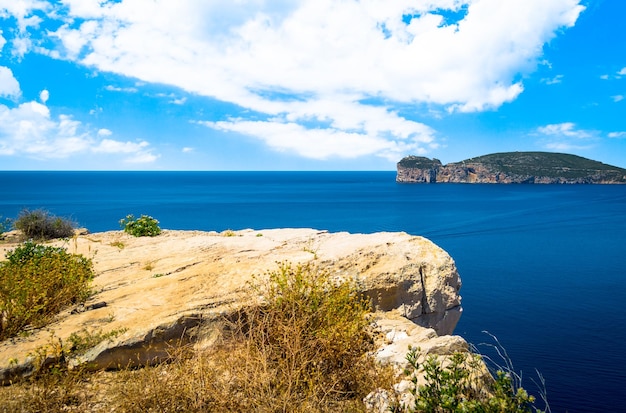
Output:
top-left (0, 0), bottom-right (584, 158)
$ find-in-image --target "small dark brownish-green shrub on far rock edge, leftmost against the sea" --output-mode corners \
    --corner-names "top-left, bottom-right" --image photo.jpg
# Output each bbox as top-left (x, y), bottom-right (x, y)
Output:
top-left (13, 209), bottom-right (75, 240)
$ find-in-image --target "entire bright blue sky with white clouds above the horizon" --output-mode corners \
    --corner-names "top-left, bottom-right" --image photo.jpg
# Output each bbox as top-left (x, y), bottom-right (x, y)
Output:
top-left (0, 0), bottom-right (626, 170)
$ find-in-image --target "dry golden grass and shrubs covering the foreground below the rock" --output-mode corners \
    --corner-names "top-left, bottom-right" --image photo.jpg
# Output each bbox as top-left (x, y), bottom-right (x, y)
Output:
top-left (0, 263), bottom-right (536, 413)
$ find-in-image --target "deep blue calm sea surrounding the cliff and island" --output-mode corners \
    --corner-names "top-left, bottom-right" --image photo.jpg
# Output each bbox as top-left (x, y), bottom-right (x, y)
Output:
top-left (0, 172), bottom-right (626, 412)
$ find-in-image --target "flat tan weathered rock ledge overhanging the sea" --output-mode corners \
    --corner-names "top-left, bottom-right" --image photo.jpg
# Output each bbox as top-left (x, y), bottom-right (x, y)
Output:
top-left (0, 229), bottom-right (466, 381)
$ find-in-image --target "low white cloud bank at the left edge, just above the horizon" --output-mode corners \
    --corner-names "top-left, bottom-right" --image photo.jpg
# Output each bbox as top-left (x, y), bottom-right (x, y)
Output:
top-left (0, 101), bottom-right (158, 162)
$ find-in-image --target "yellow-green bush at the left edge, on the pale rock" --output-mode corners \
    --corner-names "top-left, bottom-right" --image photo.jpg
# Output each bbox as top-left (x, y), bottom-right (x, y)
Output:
top-left (0, 241), bottom-right (94, 340)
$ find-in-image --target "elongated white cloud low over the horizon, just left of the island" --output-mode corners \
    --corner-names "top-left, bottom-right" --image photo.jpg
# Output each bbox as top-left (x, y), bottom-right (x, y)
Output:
top-left (199, 97), bottom-right (435, 160)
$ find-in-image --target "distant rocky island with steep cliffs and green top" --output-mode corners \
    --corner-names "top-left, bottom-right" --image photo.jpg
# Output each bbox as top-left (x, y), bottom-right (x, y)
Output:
top-left (396, 152), bottom-right (626, 184)
